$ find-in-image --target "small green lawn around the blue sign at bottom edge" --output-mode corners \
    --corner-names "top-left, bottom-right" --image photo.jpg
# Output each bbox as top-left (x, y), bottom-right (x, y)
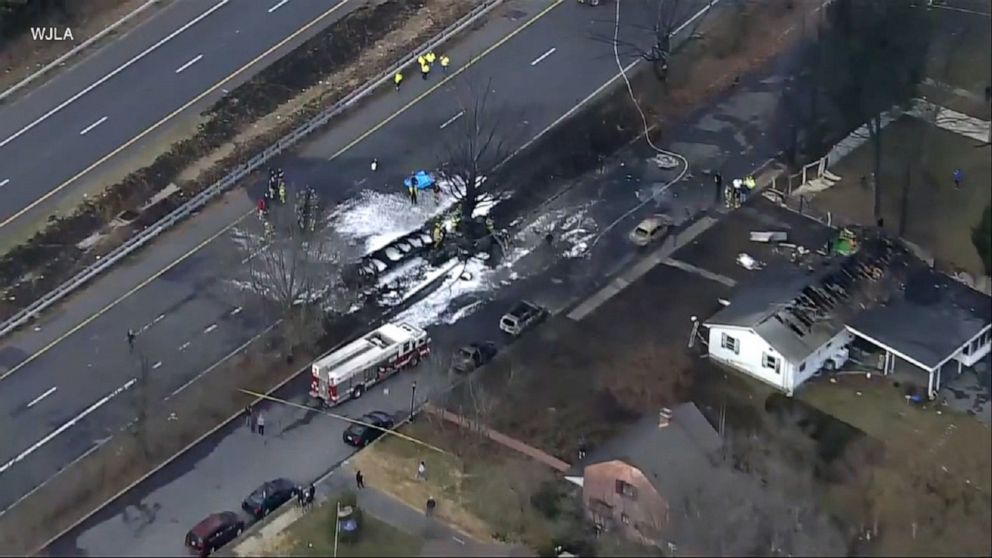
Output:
top-left (273, 500), bottom-right (424, 557)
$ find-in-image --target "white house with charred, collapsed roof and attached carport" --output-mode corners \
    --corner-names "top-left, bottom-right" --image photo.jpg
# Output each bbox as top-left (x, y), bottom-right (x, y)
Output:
top-left (703, 238), bottom-right (992, 397)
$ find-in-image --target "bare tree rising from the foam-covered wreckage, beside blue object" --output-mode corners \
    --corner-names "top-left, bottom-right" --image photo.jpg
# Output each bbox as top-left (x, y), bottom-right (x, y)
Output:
top-left (438, 79), bottom-right (508, 237)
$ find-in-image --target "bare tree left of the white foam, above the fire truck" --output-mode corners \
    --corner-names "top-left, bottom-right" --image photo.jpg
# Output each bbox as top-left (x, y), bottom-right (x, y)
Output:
top-left (239, 188), bottom-right (348, 354)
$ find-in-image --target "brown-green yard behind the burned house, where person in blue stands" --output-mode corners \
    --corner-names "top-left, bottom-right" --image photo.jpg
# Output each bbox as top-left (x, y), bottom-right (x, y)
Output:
top-left (812, 116), bottom-right (992, 276)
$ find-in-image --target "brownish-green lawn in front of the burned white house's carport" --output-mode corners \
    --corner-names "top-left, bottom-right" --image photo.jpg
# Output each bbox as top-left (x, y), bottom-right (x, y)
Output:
top-left (801, 377), bottom-right (992, 556)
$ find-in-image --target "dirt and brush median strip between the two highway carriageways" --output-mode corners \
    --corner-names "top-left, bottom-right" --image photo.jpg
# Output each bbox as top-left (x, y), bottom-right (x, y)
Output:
top-left (0, 0), bottom-right (473, 324)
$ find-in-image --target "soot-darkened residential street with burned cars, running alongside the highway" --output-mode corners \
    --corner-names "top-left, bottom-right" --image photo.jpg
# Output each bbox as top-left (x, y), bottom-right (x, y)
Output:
top-left (42, 47), bottom-right (781, 555)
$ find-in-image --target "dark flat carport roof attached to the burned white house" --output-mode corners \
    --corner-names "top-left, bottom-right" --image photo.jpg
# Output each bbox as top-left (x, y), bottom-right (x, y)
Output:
top-left (848, 265), bottom-right (992, 369)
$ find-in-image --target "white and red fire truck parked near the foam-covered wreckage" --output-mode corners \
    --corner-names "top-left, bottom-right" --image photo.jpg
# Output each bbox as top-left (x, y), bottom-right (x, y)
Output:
top-left (310, 322), bottom-right (431, 406)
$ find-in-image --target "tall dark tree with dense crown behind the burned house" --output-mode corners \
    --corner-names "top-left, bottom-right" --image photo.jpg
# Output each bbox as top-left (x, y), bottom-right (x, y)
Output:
top-left (817, 0), bottom-right (930, 223)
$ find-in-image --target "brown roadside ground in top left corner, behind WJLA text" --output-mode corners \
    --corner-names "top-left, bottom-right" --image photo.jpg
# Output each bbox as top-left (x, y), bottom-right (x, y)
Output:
top-left (0, 0), bottom-right (164, 96)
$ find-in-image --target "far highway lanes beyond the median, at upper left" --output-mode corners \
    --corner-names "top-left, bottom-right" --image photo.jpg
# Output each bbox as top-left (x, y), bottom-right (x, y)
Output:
top-left (0, 0), bottom-right (361, 231)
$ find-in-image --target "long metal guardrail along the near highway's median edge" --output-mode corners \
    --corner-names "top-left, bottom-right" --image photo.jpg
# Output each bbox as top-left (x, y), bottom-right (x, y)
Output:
top-left (0, 0), bottom-right (503, 337)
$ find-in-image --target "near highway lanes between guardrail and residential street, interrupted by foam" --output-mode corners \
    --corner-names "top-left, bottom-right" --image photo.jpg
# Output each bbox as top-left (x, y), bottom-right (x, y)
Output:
top-left (0, 0), bottom-right (720, 552)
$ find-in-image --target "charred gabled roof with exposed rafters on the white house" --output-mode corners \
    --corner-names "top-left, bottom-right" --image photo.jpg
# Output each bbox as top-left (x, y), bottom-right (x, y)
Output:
top-left (706, 236), bottom-right (909, 362)
